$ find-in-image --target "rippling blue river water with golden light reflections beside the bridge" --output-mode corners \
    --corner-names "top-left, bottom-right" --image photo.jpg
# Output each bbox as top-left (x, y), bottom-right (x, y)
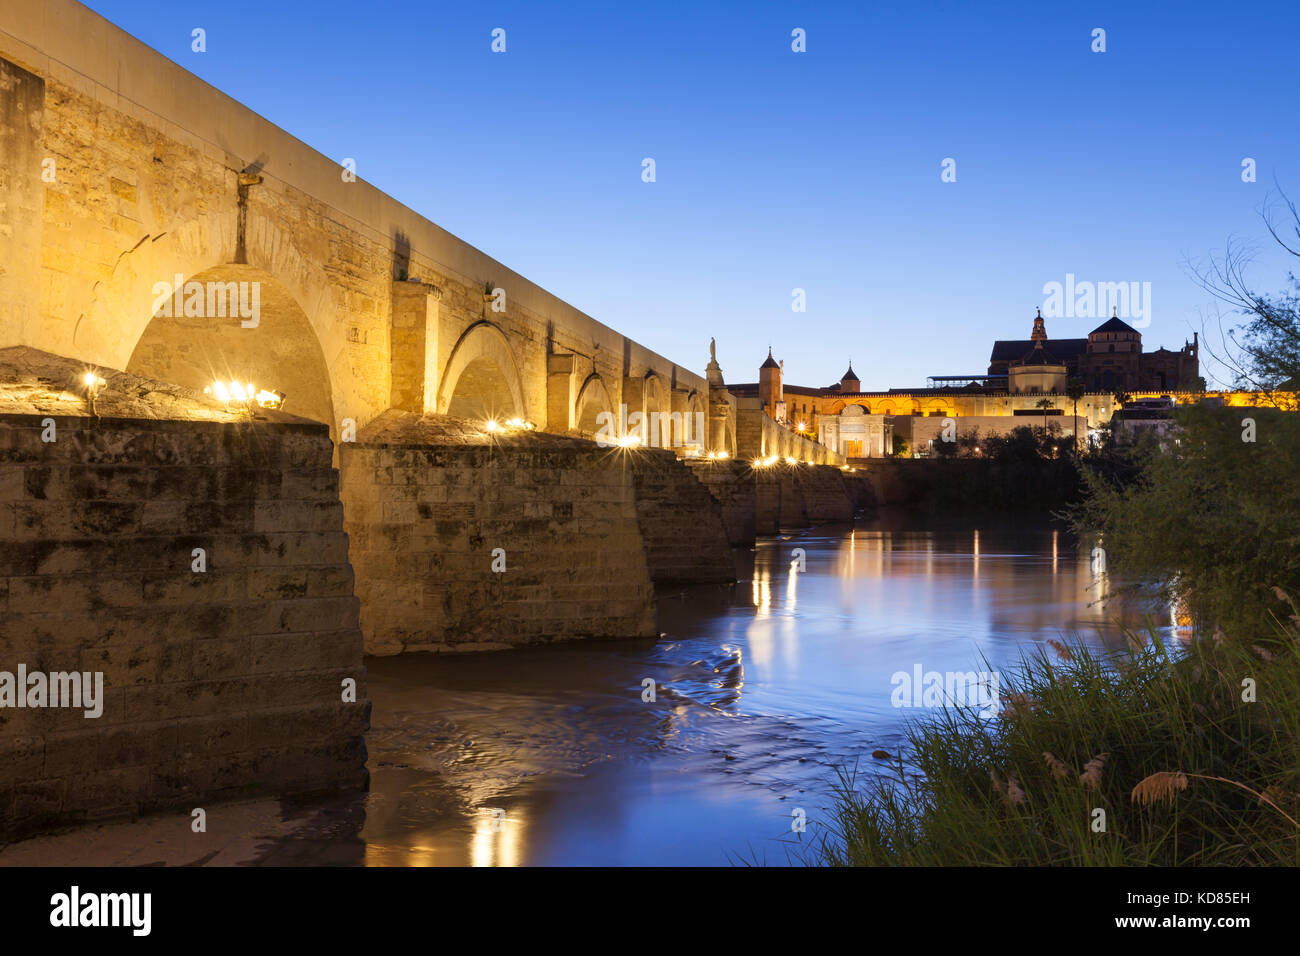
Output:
top-left (348, 523), bottom-right (1167, 866)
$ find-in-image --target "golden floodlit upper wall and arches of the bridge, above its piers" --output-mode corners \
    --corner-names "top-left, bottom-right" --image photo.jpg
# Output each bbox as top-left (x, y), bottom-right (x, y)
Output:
top-left (0, 0), bottom-right (717, 451)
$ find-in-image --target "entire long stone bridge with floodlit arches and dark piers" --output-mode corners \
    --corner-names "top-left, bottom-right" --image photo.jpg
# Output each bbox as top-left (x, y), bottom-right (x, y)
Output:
top-left (0, 0), bottom-right (862, 843)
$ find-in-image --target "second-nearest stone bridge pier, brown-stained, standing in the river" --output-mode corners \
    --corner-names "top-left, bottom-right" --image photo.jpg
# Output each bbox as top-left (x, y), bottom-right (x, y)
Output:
top-left (339, 411), bottom-right (655, 654)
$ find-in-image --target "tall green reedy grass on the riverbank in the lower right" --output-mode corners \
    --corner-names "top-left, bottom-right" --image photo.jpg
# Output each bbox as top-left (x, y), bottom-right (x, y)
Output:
top-left (810, 617), bottom-right (1300, 866)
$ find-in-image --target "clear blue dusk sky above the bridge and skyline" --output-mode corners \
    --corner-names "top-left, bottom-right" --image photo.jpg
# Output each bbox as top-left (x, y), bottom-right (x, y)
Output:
top-left (88, 0), bottom-right (1300, 388)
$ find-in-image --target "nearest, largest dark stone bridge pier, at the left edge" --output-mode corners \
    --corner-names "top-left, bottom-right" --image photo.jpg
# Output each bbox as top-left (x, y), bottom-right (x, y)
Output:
top-left (0, 349), bottom-right (369, 840)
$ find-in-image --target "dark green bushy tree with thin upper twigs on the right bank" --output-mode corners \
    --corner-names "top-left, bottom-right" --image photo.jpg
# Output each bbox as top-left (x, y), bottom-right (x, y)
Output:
top-left (1074, 183), bottom-right (1300, 640)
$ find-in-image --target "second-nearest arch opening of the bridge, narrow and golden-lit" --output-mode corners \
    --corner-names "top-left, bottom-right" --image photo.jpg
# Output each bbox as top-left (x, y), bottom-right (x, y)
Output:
top-left (438, 320), bottom-right (528, 420)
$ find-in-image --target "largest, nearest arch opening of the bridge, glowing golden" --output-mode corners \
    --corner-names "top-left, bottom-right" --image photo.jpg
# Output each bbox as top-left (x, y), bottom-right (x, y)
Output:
top-left (125, 263), bottom-right (335, 434)
